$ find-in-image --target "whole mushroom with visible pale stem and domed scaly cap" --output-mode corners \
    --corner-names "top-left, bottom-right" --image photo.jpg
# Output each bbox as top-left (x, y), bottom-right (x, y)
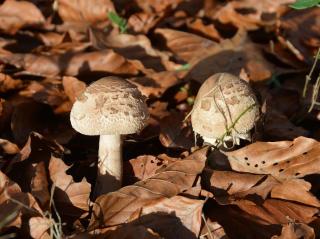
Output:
top-left (70, 77), bottom-right (149, 196)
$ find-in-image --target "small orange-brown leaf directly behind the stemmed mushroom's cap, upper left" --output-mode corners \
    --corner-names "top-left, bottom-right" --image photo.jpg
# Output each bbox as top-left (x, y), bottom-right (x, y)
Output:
top-left (62, 76), bottom-right (86, 103)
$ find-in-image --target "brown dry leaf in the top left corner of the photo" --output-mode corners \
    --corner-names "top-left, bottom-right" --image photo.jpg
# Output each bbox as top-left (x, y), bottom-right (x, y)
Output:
top-left (0, 0), bottom-right (45, 34)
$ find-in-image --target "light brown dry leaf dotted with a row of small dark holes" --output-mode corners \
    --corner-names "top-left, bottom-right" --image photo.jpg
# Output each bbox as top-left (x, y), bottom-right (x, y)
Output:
top-left (224, 137), bottom-right (320, 180)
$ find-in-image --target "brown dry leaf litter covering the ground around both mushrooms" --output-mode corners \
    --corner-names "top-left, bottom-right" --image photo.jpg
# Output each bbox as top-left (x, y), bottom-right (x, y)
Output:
top-left (0, 0), bottom-right (320, 239)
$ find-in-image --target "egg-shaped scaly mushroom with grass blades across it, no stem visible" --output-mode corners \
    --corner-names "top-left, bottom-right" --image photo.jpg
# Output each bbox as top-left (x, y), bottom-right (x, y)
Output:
top-left (191, 73), bottom-right (259, 146)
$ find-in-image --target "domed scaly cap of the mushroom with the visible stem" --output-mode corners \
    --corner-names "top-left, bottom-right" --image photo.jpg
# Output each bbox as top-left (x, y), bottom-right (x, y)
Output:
top-left (70, 77), bottom-right (149, 135)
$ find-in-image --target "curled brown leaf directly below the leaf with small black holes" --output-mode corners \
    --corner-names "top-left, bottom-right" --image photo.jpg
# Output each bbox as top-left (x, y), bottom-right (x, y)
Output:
top-left (202, 170), bottom-right (320, 207)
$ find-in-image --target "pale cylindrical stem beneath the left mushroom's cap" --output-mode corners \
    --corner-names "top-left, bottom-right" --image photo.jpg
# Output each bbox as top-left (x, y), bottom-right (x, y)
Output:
top-left (95, 134), bottom-right (122, 196)
